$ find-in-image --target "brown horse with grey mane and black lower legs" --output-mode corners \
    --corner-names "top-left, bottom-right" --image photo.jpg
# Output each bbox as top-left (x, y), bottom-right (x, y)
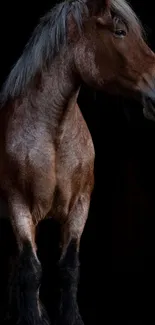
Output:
top-left (0, 0), bottom-right (155, 325)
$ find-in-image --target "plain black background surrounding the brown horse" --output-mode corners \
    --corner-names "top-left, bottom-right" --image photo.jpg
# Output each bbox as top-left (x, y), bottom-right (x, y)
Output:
top-left (0, 0), bottom-right (155, 325)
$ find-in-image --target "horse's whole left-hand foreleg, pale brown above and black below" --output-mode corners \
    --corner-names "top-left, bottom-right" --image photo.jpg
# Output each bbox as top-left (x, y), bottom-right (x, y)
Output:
top-left (5, 196), bottom-right (47, 325)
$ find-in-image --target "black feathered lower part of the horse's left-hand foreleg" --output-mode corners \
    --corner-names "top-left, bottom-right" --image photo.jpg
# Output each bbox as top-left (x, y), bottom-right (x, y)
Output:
top-left (5, 242), bottom-right (47, 325)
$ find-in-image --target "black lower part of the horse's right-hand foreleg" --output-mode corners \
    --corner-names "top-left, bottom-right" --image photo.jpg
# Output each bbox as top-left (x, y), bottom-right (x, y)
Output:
top-left (58, 239), bottom-right (83, 325)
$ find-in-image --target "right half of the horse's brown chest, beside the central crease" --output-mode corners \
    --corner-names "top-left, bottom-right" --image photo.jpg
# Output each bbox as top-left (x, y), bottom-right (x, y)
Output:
top-left (52, 117), bottom-right (95, 217)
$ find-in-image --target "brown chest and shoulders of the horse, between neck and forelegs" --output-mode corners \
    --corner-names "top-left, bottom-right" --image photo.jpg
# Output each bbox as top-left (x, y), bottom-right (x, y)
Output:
top-left (0, 60), bottom-right (94, 246)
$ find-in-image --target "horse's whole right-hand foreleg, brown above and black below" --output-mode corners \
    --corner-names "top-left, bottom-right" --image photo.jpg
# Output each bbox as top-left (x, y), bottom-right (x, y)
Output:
top-left (57, 197), bottom-right (89, 325)
